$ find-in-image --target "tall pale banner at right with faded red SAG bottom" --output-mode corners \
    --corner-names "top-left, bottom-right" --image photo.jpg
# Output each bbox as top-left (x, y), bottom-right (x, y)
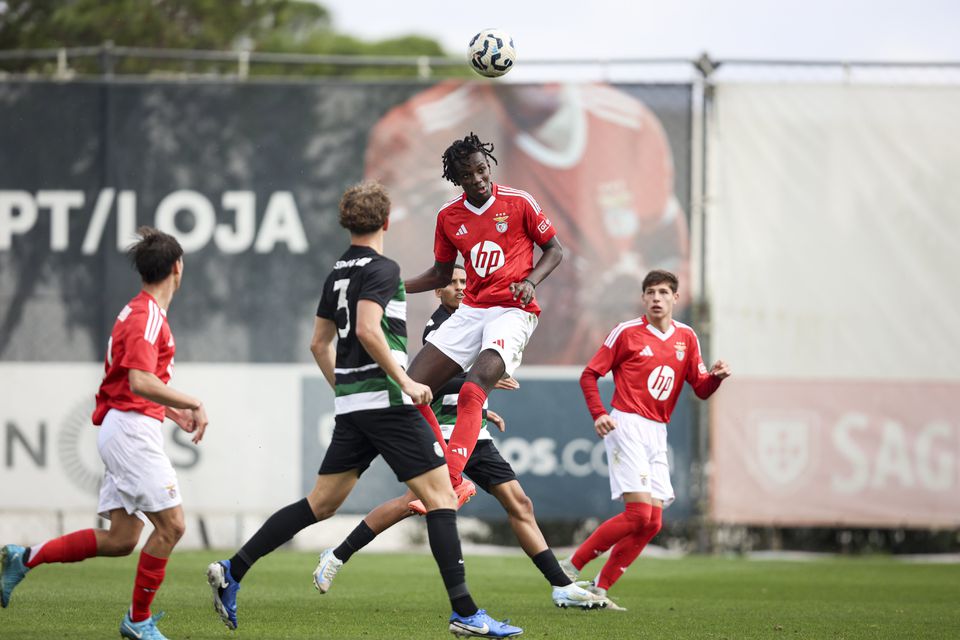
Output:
top-left (706, 84), bottom-right (960, 527)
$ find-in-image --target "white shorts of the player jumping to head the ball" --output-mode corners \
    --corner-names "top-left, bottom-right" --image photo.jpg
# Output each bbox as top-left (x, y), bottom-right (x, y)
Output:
top-left (427, 304), bottom-right (540, 376)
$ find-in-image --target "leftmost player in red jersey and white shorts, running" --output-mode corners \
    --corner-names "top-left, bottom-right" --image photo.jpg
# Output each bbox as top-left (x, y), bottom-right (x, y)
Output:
top-left (2, 227), bottom-right (207, 640)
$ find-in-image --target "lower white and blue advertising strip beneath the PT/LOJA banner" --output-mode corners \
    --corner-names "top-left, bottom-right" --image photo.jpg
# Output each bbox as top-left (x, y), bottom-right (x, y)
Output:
top-left (0, 363), bottom-right (693, 520)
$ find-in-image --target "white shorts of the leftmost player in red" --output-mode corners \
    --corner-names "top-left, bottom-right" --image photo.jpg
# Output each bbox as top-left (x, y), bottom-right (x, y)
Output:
top-left (97, 409), bottom-right (183, 520)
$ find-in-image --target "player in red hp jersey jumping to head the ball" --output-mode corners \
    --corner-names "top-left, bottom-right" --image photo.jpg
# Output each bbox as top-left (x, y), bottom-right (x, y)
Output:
top-left (404, 133), bottom-right (563, 504)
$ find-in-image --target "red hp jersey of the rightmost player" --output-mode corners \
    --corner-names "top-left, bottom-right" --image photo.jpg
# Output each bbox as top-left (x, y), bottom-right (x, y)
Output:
top-left (580, 316), bottom-right (720, 424)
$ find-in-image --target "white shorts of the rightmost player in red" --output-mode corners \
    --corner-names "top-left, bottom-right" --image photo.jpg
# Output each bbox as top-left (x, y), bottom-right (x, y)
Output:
top-left (603, 409), bottom-right (675, 508)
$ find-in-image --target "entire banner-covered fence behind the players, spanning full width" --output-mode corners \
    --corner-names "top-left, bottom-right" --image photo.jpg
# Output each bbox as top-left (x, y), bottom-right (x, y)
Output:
top-left (0, 46), bottom-right (960, 550)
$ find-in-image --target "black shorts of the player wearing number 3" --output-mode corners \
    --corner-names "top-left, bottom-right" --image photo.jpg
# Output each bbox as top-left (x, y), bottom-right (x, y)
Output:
top-left (317, 405), bottom-right (446, 482)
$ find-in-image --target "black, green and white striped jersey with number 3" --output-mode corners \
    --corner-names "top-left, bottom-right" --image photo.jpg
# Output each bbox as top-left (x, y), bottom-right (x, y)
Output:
top-left (317, 246), bottom-right (404, 415)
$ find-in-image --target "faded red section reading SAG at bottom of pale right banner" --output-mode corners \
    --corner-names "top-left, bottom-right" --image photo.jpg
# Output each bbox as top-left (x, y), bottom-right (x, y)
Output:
top-left (710, 379), bottom-right (960, 528)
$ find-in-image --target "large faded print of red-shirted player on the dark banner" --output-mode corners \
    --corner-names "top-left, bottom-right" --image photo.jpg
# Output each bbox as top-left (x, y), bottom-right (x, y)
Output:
top-left (366, 82), bottom-right (690, 364)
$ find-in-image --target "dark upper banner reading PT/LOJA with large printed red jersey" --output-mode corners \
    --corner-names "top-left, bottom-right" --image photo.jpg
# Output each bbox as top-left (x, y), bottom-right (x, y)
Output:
top-left (0, 82), bottom-right (691, 364)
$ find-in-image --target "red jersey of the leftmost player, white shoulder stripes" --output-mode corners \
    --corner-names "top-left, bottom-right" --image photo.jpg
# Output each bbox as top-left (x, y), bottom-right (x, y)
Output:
top-left (93, 291), bottom-right (176, 425)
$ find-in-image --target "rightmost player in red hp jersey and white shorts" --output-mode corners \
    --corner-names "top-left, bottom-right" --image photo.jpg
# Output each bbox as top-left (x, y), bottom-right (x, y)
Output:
top-left (560, 270), bottom-right (730, 608)
